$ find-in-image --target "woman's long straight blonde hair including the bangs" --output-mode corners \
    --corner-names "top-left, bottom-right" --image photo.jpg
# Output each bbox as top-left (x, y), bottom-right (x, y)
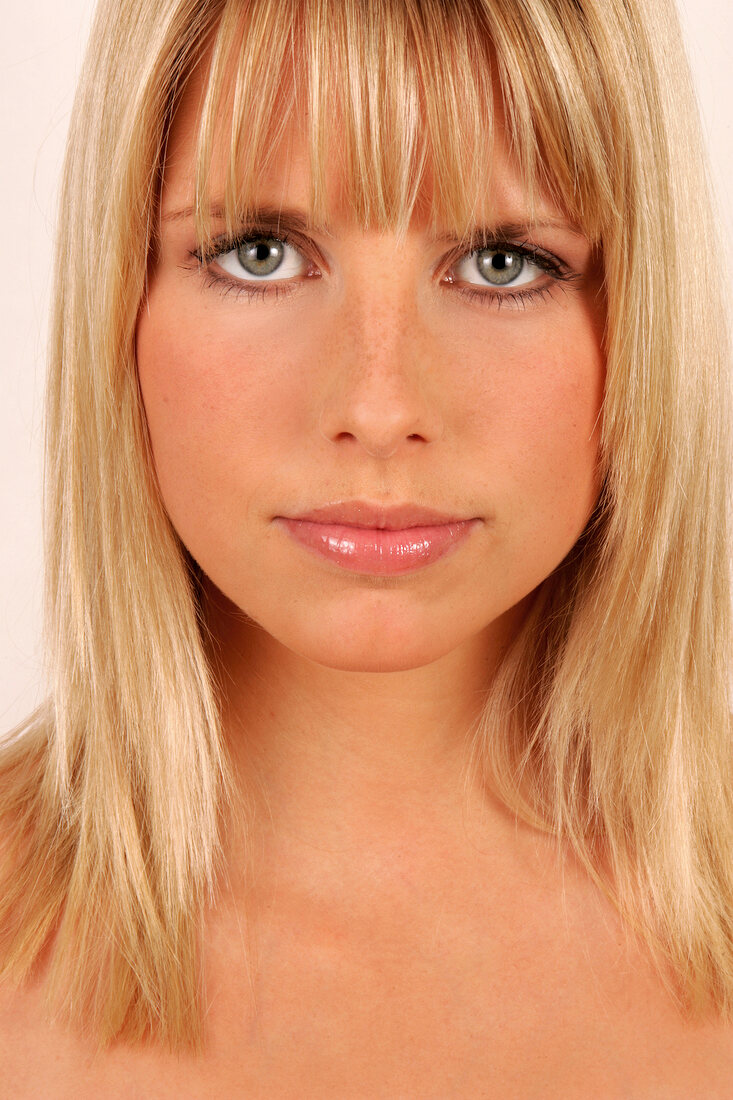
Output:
top-left (0, 0), bottom-right (733, 1047)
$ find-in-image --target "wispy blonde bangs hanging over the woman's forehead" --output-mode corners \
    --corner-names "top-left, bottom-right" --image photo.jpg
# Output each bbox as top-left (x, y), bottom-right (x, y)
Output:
top-left (188, 0), bottom-right (620, 250)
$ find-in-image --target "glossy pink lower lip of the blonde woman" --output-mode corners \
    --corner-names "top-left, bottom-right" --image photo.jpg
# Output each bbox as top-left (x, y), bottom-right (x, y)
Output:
top-left (278, 517), bottom-right (480, 576)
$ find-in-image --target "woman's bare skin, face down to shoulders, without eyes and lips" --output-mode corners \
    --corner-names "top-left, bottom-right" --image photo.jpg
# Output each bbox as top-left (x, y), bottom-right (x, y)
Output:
top-left (0, 70), bottom-right (733, 1100)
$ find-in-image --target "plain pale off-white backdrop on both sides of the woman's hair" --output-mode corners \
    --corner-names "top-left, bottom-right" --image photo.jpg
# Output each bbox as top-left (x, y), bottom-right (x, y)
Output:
top-left (0, 0), bottom-right (733, 732)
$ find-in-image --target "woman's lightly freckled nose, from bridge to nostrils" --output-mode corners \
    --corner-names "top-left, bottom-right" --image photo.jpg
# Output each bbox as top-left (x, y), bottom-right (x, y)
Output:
top-left (319, 299), bottom-right (444, 459)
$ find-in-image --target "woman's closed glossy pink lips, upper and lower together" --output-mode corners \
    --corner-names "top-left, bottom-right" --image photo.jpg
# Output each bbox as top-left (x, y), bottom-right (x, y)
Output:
top-left (277, 501), bottom-right (480, 576)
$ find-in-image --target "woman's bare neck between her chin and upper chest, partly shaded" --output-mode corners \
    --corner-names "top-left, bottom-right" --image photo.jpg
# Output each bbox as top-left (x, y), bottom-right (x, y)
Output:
top-left (202, 591), bottom-right (524, 844)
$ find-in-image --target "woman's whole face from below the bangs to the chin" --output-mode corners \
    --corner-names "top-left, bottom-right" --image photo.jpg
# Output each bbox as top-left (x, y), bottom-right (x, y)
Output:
top-left (138, 79), bottom-right (604, 671)
